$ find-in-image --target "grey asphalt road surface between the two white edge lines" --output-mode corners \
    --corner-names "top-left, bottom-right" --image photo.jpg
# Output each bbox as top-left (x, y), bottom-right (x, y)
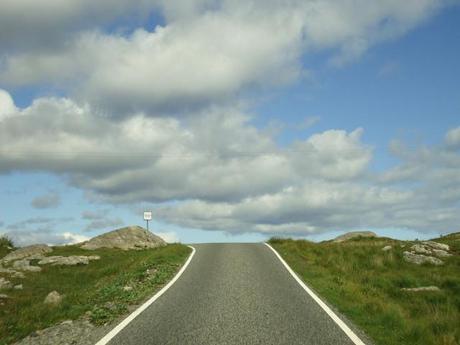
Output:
top-left (109, 244), bottom-right (358, 345)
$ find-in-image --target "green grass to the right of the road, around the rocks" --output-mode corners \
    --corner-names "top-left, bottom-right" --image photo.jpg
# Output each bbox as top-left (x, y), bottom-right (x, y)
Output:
top-left (269, 234), bottom-right (460, 345)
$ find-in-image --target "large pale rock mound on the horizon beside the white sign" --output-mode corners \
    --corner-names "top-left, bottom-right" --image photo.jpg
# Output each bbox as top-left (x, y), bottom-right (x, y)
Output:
top-left (81, 226), bottom-right (166, 250)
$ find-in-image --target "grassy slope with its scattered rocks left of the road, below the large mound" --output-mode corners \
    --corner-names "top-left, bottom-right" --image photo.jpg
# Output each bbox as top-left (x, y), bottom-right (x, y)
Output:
top-left (0, 228), bottom-right (191, 345)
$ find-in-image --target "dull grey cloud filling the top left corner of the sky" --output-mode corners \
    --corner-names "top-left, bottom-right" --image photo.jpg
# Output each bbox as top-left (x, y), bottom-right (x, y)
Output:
top-left (0, 0), bottom-right (156, 54)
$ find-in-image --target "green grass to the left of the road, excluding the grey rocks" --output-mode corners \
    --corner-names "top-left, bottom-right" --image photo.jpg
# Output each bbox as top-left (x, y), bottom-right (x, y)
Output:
top-left (0, 244), bottom-right (191, 345)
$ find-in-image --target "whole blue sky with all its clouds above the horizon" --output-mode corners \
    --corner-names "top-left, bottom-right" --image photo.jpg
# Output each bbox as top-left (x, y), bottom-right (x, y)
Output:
top-left (0, 0), bottom-right (460, 246)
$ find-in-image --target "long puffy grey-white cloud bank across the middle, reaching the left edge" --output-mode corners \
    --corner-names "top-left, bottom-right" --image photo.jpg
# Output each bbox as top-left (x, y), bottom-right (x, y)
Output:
top-left (0, 92), bottom-right (371, 204)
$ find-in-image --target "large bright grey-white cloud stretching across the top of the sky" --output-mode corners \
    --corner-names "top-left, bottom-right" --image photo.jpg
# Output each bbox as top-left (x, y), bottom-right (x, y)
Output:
top-left (0, 0), bottom-right (450, 115)
